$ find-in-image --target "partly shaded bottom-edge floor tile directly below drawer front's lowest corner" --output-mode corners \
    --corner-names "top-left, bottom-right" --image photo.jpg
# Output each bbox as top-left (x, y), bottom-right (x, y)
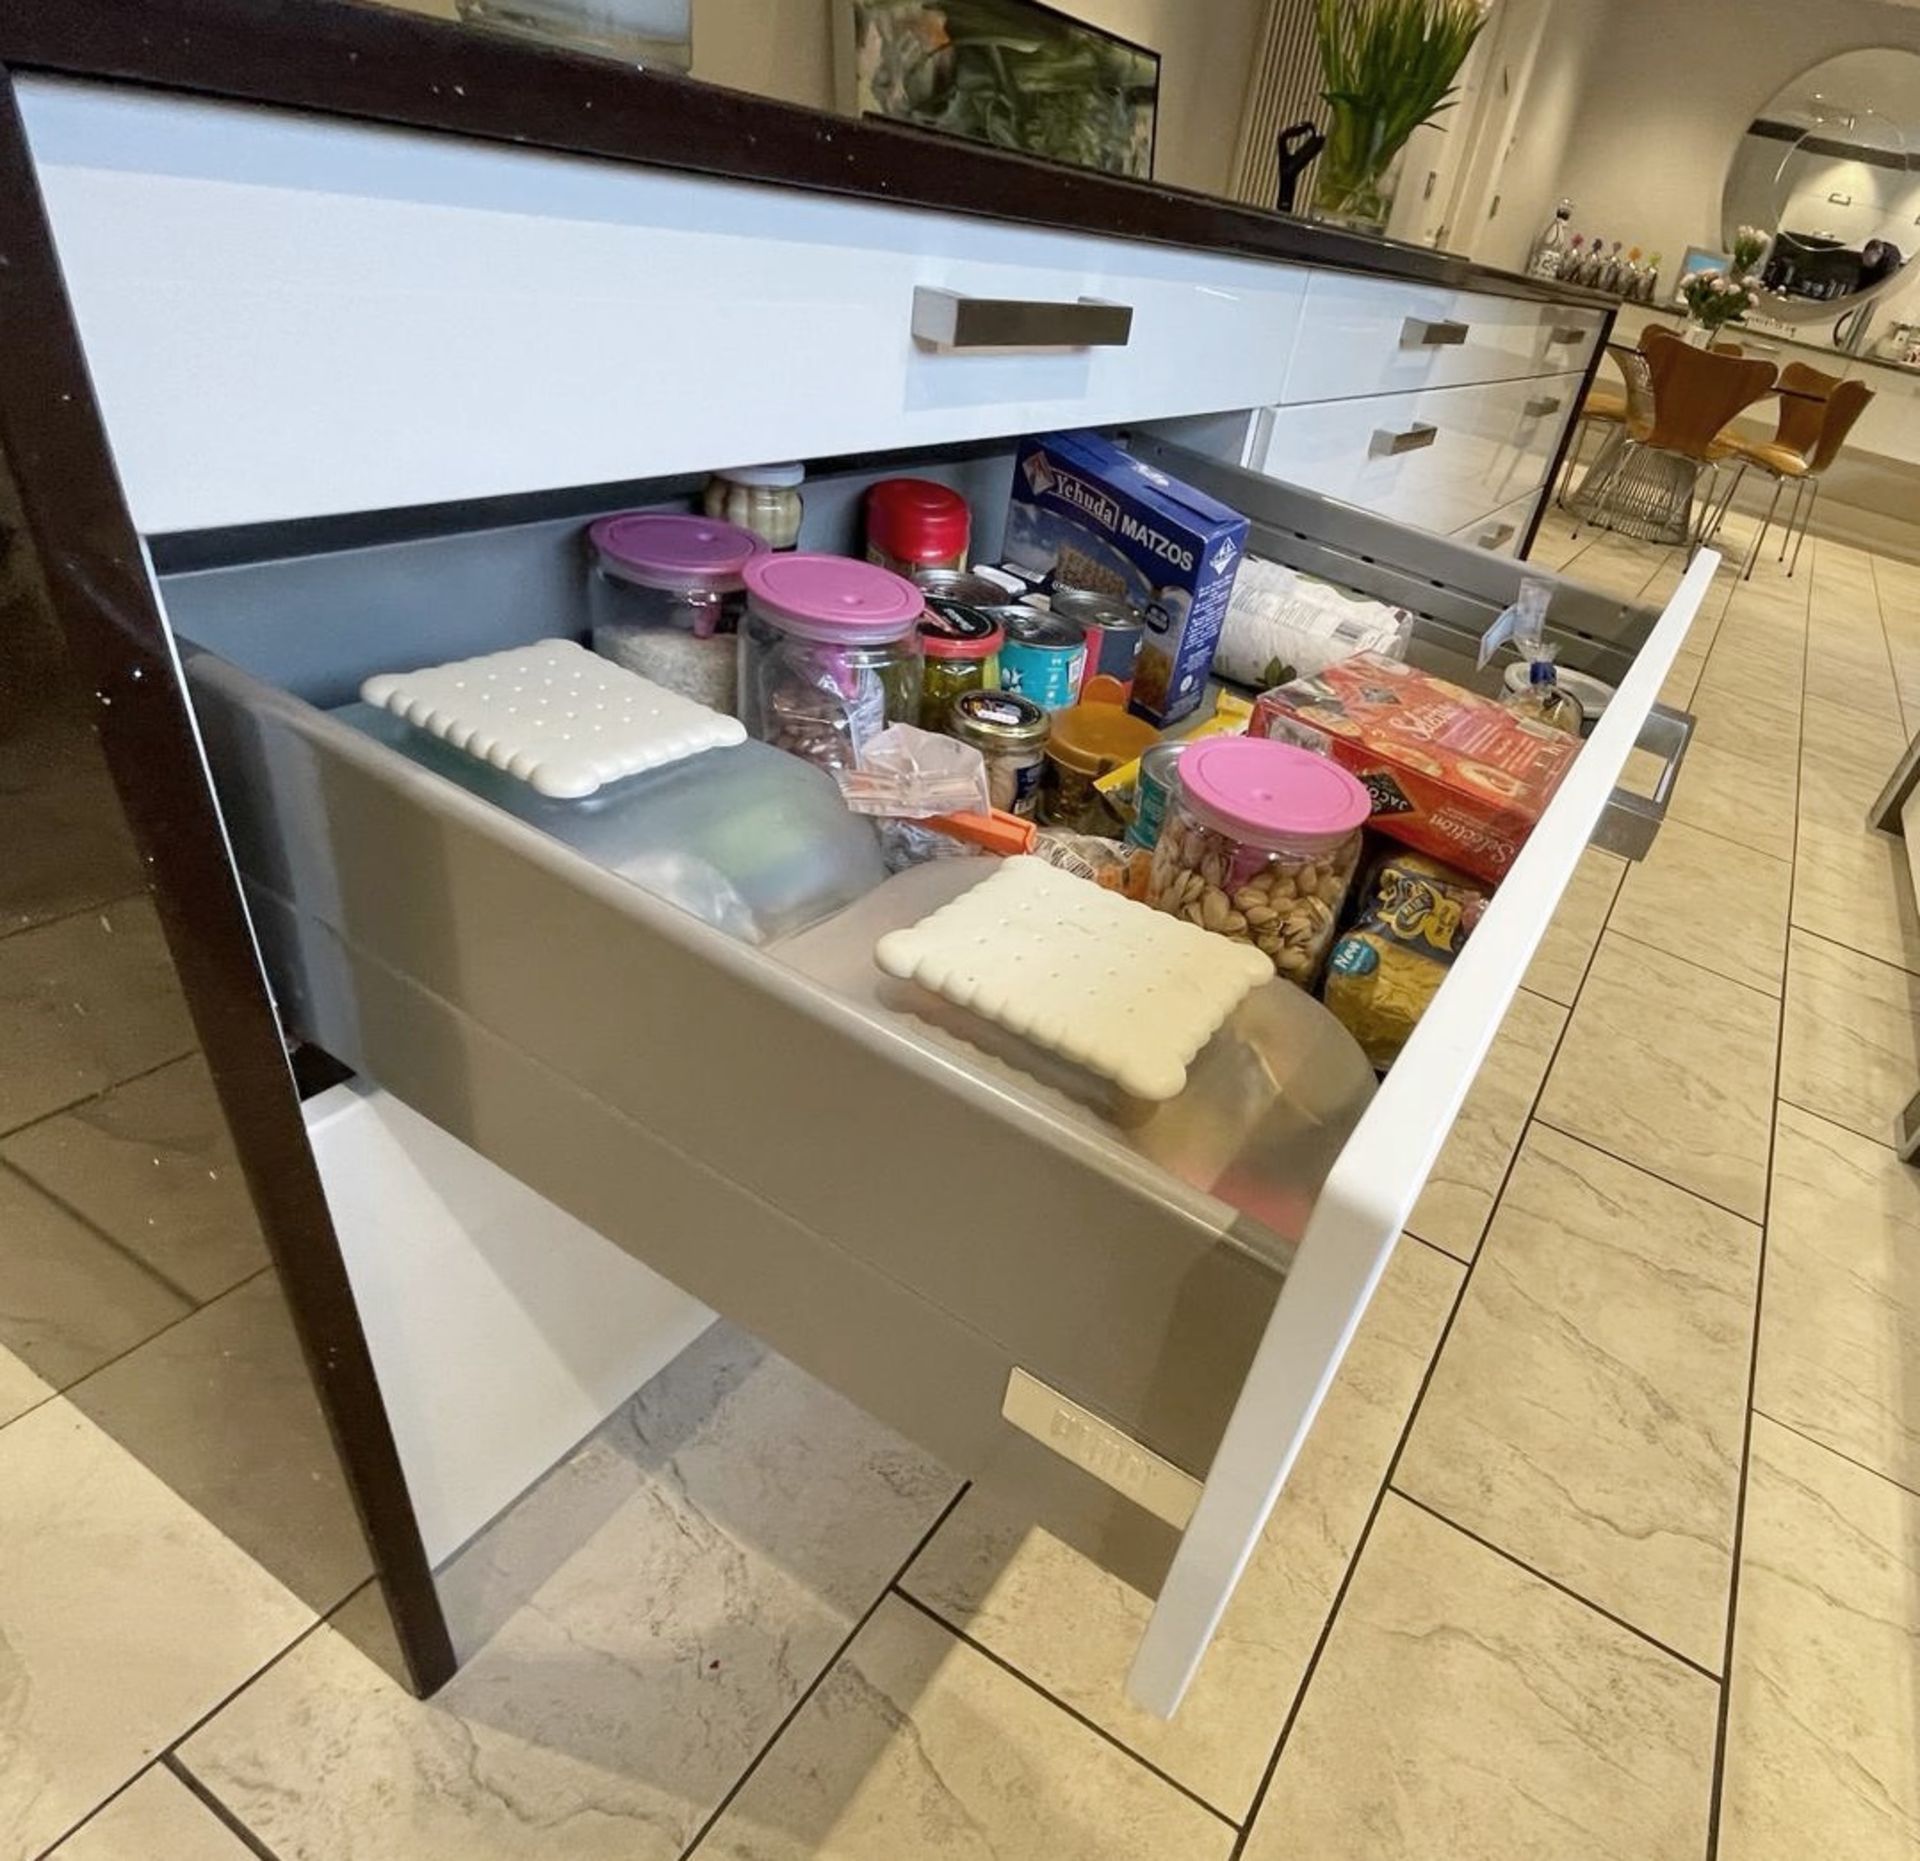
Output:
top-left (693, 1596), bottom-right (1235, 1861)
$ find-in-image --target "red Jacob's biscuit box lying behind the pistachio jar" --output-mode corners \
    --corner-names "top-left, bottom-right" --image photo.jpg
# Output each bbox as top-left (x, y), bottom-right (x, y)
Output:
top-left (1250, 653), bottom-right (1580, 882)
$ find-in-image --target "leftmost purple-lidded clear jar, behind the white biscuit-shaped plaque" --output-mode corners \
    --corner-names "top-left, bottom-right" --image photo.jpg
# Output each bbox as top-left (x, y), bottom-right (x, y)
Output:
top-left (588, 511), bottom-right (766, 714)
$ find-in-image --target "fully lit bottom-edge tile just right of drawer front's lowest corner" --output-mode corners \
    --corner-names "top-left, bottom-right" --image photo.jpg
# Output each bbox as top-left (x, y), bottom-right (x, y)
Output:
top-left (1246, 1494), bottom-right (1718, 1861)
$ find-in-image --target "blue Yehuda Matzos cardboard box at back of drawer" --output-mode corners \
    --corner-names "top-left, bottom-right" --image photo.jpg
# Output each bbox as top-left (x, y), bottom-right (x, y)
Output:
top-left (1006, 432), bottom-right (1248, 726)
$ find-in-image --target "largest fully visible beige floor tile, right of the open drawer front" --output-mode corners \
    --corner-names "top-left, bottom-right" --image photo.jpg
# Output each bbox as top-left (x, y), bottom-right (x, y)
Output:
top-left (1394, 1125), bottom-right (1761, 1671)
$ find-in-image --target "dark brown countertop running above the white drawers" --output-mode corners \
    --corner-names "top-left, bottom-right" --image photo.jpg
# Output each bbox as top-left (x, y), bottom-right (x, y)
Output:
top-left (0, 0), bottom-right (1613, 309)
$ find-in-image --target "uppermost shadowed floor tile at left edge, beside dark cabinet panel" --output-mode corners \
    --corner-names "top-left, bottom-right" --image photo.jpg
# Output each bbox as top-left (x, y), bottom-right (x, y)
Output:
top-left (0, 899), bottom-right (194, 1131)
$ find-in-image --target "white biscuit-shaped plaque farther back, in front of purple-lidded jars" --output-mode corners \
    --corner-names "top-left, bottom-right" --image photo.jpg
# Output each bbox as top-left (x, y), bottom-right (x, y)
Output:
top-left (361, 640), bottom-right (747, 801)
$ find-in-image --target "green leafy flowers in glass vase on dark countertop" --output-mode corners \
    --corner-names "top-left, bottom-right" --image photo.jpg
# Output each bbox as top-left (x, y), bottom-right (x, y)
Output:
top-left (1313, 0), bottom-right (1486, 232)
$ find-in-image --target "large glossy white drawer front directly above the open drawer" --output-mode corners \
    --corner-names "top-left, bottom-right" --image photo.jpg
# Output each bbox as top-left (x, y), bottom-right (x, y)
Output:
top-left (21, 83), bottom-right (1306, 532)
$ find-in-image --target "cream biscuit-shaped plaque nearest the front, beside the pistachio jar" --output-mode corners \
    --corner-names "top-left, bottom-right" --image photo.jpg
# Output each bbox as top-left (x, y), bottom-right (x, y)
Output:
top-left (874, 858), bottom-right (1273, 1099)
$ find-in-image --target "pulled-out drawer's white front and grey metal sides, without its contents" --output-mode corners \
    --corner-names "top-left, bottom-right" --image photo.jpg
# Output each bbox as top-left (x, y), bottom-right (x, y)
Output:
top-left (163, 434), bottom-right (1711, 1711)
